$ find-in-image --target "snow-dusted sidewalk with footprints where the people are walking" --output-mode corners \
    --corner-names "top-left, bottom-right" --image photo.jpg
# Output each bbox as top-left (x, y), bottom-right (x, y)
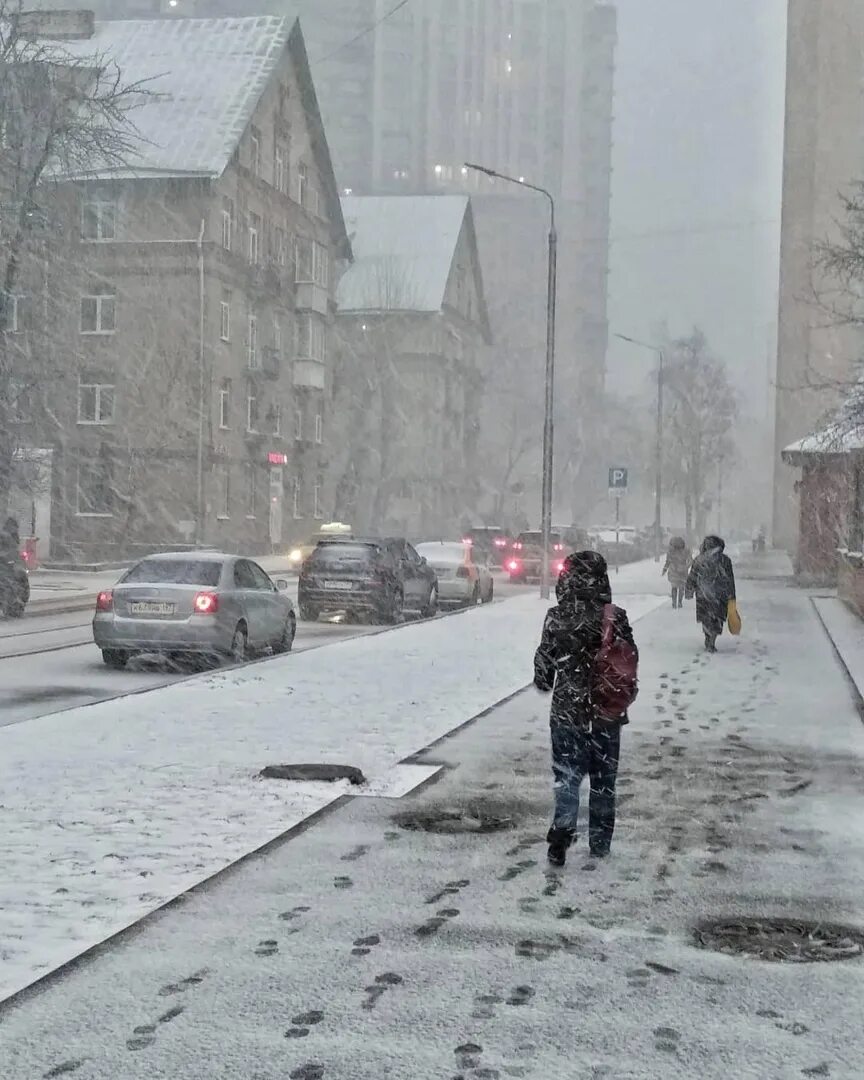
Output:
top-left (0, 565), bottom-right (864, 1080)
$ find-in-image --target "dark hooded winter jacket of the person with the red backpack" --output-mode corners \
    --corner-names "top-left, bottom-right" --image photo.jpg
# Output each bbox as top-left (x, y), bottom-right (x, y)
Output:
top-left (534, 551), bottom-right (635, 730)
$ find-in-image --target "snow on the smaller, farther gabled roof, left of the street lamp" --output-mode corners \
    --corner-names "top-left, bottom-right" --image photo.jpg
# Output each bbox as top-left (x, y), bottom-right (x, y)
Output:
top-left (337, 195), bottom-right (468, 311)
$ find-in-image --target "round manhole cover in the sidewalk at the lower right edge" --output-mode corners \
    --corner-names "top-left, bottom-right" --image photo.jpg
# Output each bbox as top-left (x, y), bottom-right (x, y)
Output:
top-left (694, 919), bottom-right (864, 963)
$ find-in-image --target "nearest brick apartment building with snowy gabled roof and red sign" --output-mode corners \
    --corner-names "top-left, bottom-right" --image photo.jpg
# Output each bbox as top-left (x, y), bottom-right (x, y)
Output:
top-left (5, 16), bottom-right (351, 562)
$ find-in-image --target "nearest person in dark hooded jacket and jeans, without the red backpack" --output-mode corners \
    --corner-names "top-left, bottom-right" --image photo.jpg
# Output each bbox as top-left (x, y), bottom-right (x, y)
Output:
top-left (534, 551), bottom-right (635, 866)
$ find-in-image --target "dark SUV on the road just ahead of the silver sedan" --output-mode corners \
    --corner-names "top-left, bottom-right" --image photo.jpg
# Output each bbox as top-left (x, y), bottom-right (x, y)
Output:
top-left (298, 537), bottom-right (438, 623)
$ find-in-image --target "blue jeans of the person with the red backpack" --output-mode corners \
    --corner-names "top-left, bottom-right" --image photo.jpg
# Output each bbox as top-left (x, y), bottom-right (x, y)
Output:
top-left (552, 724), bottom-right (621, 849)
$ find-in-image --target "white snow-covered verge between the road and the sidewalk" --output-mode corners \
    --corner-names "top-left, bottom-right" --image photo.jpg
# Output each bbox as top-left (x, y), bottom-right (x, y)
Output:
top-left (0, 564), bottom-right (662, 999)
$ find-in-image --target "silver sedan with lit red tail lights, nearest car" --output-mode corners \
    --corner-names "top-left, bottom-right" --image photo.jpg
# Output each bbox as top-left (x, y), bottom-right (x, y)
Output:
top-left (93, 552), bottom-right (297, 667)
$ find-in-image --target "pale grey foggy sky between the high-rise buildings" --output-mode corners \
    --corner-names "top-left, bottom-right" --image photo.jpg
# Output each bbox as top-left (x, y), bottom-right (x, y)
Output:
top-left (609, 0), bottom-right (786, 417)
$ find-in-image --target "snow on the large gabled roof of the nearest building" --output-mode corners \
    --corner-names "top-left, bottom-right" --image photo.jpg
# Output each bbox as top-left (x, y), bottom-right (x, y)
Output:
top-left (56, 15), bottom-right (293, 176)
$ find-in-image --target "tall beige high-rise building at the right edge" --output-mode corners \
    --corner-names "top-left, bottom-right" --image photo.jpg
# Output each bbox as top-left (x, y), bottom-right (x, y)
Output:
top-left (773, 0), bottom-right (864, 550)
